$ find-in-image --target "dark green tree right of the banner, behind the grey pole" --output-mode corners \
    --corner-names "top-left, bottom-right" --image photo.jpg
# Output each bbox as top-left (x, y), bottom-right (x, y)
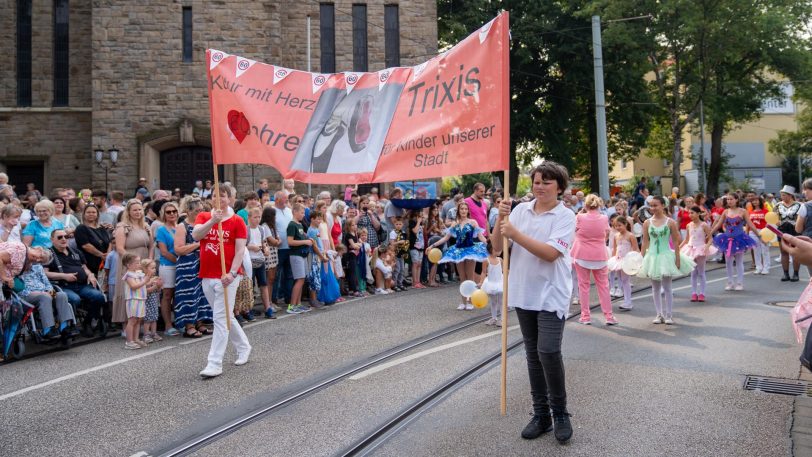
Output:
top-left (438, 0), bottom-right (650, 194)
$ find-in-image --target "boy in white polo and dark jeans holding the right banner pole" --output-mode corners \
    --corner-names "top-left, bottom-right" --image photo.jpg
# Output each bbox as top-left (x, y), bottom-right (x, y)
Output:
top-left (491, 161), bottom-right (575, 443)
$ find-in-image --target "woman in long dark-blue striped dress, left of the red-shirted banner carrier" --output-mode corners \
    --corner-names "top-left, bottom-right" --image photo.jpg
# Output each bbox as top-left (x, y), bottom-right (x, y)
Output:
top-left (175, 197), bottom-right (212, 338)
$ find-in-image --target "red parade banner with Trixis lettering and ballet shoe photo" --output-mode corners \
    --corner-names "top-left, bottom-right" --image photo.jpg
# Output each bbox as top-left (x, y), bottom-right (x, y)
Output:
top-left (206, 12), bottom-right (510, 184)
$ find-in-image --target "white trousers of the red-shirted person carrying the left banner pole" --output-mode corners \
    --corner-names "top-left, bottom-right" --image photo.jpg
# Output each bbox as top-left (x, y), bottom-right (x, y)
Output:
top-left (202, 276), bottom-right (251, 368)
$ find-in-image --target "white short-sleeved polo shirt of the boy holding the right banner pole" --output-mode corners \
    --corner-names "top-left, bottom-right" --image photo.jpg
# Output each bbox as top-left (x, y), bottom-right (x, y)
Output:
top-left (508, 199), bottom-right (575, 319)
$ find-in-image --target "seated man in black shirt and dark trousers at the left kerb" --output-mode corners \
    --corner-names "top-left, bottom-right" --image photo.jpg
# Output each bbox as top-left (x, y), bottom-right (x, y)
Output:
top-left (45, 229), bottom-right (105, 337)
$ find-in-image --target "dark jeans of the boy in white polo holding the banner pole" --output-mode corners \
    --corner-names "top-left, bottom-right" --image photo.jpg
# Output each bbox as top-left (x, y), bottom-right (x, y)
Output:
top-left (516, 308), bottom-right (567, 415)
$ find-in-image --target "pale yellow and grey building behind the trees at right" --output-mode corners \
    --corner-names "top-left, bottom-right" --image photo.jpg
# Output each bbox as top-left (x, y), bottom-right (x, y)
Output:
top-left (610, 84), bottom-right (801, 194)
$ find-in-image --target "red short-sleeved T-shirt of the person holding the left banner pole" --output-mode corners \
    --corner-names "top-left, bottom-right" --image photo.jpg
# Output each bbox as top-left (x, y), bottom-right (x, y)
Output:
top-left (195, 212), bottom-right (248, 279)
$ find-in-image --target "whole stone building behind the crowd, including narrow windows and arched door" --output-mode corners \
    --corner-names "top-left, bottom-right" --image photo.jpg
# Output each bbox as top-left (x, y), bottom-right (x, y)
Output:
top-left (0, 0), bottom-right (437, 193)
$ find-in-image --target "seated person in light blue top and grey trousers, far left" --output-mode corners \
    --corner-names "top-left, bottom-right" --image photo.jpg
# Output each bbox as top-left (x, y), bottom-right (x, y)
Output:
top-left (20, 263), bottom-right (79, 339)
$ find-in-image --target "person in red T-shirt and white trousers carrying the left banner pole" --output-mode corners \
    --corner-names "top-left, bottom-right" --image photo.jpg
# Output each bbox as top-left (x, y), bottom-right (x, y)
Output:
top-left (192, 184), bottom-right (251, 378)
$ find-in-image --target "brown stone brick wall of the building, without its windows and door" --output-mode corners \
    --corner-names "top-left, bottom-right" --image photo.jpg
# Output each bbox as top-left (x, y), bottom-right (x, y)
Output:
top-left (0, 0), bottom-right (437, 198)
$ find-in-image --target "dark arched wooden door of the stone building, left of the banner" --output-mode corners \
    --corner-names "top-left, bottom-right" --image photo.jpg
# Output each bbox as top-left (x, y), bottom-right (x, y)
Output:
top-left (161, 146), bottom-right (223, 194)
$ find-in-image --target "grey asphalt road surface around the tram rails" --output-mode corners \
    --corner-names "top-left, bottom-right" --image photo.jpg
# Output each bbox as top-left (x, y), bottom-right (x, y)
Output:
top-left (0, 256), bottom-right (804, 456)
